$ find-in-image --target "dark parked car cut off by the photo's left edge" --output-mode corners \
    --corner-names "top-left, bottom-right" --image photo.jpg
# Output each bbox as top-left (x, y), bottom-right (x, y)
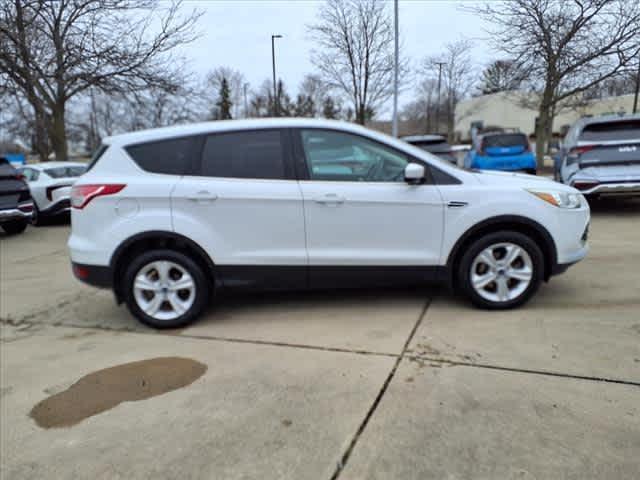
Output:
top-left (0, 157), bottom-right (33, 234)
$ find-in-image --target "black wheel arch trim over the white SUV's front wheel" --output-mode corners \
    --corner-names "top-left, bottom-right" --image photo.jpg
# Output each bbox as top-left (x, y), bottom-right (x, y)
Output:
top-left (446, 215), bottom-right (558, 285)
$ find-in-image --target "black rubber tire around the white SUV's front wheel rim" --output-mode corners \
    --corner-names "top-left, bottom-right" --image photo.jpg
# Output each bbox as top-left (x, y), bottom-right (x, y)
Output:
top-left (457, 231), bottom-right (544, 310)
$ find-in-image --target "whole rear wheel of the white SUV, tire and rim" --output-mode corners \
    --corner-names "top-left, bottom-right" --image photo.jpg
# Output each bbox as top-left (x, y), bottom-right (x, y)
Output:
top-left (123, 250), bottom-right (210, 328)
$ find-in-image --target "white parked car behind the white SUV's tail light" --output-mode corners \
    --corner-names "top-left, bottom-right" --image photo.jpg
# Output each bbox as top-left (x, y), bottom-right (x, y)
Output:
top-left (17, 162), bottom-right (87, 225)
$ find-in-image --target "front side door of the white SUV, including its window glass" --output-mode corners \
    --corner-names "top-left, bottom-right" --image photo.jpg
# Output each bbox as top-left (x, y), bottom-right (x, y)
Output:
top-left (295, 129), bottom-right (444, 286)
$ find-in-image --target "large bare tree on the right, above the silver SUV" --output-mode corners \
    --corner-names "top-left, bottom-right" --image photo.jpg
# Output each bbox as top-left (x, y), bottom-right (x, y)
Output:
top-left (473, 0), bottom-right (640, 166)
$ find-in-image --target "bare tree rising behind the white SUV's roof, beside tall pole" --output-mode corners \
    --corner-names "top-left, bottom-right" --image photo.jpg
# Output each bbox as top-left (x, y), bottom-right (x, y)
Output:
top-left (308, 0), bottom-right (406, 125)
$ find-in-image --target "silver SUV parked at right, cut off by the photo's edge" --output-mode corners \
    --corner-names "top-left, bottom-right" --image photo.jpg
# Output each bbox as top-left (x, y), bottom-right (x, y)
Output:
top-left (555, 114), bottom-right (640, 197)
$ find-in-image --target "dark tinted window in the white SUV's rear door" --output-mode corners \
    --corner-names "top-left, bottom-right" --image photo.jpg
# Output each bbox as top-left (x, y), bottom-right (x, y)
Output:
top-left (200, 130), bottom-right (287, 180)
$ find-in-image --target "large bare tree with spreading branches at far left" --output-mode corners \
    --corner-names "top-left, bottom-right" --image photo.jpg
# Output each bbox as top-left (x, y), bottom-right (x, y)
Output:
top-left (0, 0), bottom-right (199, 158)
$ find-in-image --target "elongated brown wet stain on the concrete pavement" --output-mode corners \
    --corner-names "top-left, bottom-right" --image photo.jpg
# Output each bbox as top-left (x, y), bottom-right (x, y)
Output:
top-left (29, 357), bottom-right (207, 428)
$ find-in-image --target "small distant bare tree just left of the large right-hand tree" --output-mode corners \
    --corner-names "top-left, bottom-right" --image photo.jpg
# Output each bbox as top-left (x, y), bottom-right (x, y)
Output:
top-left (422, 40), bottom-right (475, 139)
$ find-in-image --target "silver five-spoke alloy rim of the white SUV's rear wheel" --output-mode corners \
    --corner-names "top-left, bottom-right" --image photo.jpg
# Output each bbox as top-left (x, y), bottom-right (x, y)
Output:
top-left (133, 260), bottom-right (196, 320)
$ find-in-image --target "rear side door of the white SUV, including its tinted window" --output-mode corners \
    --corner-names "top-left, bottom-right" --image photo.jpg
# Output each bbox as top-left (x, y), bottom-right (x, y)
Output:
top-left (172, 129), bottom-right (307, 288)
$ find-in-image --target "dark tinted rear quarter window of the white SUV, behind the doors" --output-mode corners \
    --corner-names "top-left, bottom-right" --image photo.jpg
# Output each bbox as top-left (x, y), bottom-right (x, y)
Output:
top-left (125, 137), bottom-right (198, 175)
